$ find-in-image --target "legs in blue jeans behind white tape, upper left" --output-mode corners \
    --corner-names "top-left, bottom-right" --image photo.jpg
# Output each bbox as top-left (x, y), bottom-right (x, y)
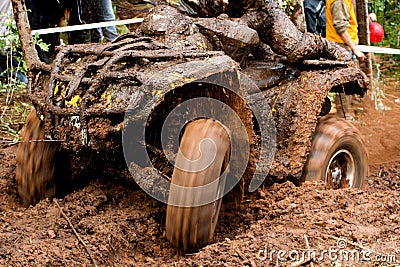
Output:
top-left (92, 0), bottom-right (118, 43)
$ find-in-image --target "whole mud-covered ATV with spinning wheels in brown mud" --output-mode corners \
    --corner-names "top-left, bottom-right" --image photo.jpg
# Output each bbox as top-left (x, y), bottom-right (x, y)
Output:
top-left (13, 0), bottom-right (368, 251)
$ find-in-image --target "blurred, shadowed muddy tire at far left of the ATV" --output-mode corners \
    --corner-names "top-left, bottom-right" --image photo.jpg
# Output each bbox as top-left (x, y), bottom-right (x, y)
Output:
top-left (16, 110), bottom-right (57, 206)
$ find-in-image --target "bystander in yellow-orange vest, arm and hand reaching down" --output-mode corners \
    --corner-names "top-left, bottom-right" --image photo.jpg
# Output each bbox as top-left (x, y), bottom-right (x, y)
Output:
top-left (326, 0), bottom-right (365, 60)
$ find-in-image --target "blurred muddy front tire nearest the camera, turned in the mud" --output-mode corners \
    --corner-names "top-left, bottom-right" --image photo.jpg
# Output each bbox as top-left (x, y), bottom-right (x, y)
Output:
top-left (166, 119), bottom-right (230, 251)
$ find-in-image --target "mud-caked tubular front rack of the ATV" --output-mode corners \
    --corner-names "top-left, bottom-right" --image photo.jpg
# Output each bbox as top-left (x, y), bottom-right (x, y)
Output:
top-left (29, 34), bottom-right (223, 117)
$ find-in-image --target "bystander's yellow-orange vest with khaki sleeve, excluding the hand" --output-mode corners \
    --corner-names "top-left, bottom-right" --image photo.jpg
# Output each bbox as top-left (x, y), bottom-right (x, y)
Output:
top-left (326, 0), bottom-right (358, 44)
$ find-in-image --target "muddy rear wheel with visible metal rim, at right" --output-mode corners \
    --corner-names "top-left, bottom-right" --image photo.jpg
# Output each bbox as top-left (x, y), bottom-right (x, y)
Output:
top-left (303, 117), bottom-right (368, 189)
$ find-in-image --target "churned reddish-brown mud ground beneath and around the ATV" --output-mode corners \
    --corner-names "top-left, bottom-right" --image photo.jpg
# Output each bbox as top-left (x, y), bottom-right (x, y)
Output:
top-left (0, 82), bottom-right (400, 266)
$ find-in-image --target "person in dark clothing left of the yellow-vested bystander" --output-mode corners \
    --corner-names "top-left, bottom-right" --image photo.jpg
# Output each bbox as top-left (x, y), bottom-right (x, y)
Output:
top-left (304, 0), bottom-right (326, 37)
